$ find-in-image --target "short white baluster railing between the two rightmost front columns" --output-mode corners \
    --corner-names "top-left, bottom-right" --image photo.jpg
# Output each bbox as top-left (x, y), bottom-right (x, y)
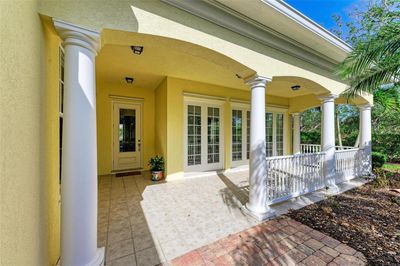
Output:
top-left (335, 148), bottom-right (364, 184)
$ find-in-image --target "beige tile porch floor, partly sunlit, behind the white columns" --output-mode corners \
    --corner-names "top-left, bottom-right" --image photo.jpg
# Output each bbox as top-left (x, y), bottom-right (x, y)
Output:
top-left (98, 171), bottom-right (364, 266)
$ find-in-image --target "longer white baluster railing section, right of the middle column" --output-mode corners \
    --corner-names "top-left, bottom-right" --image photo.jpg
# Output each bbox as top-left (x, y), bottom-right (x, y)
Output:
top-left (266, 153), bottom-right (325, 204)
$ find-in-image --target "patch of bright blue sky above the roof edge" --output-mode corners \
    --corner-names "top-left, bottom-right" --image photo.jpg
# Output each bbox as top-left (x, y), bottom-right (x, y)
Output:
top-left (285, 0), bottom-right (360, 33)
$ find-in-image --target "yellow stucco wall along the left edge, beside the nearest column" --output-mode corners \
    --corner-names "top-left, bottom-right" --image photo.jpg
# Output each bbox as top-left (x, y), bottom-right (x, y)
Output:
top-left (0, 0), bottom-right (59, 266)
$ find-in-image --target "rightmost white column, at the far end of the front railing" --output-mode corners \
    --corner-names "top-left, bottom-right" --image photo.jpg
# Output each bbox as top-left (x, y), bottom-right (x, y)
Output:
top-left (358, 104), bottom-right (372, 174)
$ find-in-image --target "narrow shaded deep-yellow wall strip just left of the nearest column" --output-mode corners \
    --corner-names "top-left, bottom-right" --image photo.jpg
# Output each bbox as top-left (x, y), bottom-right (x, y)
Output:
top-left (41, 18), bottom-right (61, 265)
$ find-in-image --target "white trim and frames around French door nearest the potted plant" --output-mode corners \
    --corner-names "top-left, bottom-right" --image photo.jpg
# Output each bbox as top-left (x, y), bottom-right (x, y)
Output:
top-left (184, 94), bottom-right (225, 172)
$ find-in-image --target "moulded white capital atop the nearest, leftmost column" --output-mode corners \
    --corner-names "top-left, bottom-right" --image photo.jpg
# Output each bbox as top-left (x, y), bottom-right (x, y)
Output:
top-left (53, 19), bottom-right (100, 54)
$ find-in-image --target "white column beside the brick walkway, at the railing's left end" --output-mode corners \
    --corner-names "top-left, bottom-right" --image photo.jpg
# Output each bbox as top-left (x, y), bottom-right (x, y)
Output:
top-left (244, 76), bottom-right (274, 221)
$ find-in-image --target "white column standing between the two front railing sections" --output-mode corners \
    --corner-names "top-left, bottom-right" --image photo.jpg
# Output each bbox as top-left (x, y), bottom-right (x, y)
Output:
top-left (320, 94), bottom-right (338, 193)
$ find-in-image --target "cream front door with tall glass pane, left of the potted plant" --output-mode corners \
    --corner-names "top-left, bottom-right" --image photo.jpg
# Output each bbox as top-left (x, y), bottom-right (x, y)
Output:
top-left (113, 102), bottom-right (142, 171)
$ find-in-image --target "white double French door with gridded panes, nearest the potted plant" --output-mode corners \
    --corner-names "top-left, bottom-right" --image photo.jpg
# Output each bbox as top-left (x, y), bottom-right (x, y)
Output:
top-left (185, 102), bottom-right (224, 171)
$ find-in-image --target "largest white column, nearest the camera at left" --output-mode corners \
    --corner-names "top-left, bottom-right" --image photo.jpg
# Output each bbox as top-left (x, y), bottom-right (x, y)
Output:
top-left (54, 20), bottom-right (104, 266)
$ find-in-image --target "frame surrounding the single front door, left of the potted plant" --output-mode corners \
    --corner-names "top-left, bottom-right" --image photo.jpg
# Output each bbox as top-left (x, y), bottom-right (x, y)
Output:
top-left (109, 95), bottom-right (145, 173)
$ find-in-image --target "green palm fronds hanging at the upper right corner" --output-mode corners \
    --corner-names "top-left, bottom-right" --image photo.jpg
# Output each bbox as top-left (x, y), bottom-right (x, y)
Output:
top-left (338, 0), bottom-right (400, 108)
